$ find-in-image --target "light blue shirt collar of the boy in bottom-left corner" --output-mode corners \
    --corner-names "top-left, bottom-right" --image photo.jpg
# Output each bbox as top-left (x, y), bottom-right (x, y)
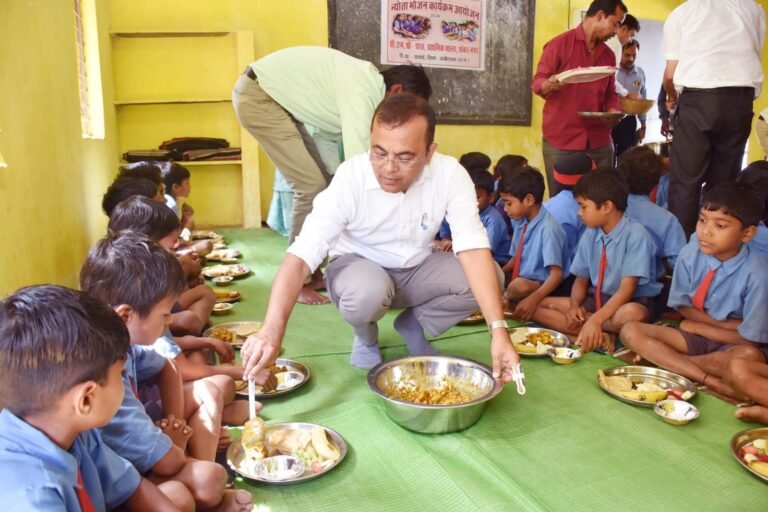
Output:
top-left (0, 409), bottom-right (78, 486)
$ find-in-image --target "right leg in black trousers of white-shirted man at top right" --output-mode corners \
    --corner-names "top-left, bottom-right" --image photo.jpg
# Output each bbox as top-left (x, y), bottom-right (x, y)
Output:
top-left (704, 87), bottom-right (754, 190)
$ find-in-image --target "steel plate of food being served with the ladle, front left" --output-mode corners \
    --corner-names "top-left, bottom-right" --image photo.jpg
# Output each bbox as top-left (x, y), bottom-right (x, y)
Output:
top-left (227, 417), bottom-right (347, 485)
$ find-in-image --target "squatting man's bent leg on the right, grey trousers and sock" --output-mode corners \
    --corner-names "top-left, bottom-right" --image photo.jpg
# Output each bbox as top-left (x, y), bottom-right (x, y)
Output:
top-left (389, 252), bottom-right (504, 355)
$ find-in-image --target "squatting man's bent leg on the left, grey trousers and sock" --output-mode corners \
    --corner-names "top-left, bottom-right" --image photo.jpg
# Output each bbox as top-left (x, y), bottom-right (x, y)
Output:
top-left (326, 254), bottom-right (395, 369)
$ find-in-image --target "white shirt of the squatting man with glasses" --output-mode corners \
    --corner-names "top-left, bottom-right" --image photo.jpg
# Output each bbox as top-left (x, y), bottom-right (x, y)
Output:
top-left (288, 153), bottom-right (490, 271)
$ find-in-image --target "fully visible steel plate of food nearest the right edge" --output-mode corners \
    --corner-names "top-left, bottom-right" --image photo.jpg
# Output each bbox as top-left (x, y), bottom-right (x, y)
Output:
top-left (597, 366), bottom-right (696, 407)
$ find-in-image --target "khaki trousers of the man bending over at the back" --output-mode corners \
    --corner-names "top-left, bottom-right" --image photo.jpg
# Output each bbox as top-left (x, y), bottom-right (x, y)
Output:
top-left (232, 75), bottom-right (335, 243)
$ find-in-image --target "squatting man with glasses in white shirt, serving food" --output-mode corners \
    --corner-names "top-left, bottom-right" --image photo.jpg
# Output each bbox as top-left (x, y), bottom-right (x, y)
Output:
top-left (242, 94), bottom-right (520, 381)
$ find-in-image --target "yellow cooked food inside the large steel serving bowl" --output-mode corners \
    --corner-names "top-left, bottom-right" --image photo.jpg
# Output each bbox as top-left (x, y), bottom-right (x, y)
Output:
top-left (382, 376), bottom-right (479, 405)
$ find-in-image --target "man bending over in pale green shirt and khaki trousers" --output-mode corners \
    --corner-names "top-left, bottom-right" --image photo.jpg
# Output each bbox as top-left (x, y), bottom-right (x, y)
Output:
top-left (232, 46), bottom-right (432, 304)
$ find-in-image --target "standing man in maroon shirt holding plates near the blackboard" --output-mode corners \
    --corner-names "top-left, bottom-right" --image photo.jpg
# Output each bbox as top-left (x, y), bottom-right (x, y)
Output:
top-left (531, 0), bottom-right (627, 197)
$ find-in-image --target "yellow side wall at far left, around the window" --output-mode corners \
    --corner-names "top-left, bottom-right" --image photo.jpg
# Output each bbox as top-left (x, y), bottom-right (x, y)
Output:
top-left (0, 0), bottom-right (117, 296)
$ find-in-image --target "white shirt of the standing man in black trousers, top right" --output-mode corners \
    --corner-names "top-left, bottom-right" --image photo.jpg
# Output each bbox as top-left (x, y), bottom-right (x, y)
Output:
top-left (664, 0), bottom-right (765, 97)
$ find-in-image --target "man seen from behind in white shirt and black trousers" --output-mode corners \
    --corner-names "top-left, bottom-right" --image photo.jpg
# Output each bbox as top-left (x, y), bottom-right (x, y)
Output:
top-left (664, 0), bottom-right (765, 235)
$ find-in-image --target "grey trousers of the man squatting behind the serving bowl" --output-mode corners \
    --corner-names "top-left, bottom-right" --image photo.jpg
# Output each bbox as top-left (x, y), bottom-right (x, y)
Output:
top-left (325, 252), bottom-right (501, 341)
